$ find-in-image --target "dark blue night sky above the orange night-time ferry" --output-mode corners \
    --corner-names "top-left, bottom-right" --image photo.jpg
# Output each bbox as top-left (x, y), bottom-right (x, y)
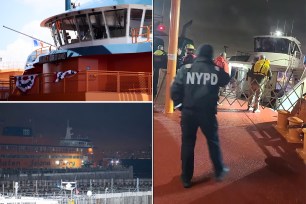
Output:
top-left (0, 103), bottom-right (152, 150)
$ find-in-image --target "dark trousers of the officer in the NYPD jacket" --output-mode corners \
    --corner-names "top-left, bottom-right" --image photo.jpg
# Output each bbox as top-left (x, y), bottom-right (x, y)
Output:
top-left (181, 109), bottom-right (223, 181)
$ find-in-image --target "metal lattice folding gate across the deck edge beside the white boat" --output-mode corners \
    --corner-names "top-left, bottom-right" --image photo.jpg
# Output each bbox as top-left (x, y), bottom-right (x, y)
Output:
top-left (219, 69), bottom-right (306, 111)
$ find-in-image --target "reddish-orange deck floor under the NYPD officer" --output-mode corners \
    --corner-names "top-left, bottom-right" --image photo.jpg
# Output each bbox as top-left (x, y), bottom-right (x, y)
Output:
top-left (154, 102), bottom-right (306, 204)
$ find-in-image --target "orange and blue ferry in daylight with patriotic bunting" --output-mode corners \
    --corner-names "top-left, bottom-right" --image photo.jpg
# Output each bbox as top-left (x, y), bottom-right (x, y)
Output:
top-left (8, 0), bottom-right (152, 101)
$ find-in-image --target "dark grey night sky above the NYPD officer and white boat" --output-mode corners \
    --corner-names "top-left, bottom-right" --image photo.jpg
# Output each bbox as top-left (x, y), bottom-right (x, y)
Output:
top-left (154, 0), bottom-right (306, 55)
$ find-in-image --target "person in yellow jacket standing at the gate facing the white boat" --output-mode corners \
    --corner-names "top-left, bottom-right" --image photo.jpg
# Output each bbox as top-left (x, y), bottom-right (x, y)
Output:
top-left (247, 55), bottom-right (272, 113)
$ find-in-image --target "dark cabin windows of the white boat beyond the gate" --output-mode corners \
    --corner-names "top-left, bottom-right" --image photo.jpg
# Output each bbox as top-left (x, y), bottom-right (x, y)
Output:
top-left (254, 37), bottom-right (289, 54)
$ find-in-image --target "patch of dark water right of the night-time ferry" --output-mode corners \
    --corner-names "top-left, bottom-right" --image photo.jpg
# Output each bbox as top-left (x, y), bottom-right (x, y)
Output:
top-left (121, 159), bottom-right (152, 178)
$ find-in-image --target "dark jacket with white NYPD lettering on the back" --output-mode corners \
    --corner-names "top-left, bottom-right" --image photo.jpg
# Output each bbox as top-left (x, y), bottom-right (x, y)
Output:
top-left (171, 57), bottom-right (230, 114)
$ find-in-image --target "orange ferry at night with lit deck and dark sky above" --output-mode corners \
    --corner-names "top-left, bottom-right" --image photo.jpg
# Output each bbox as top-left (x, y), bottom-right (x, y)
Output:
top-left (0, 122), bottom-right (94, 170)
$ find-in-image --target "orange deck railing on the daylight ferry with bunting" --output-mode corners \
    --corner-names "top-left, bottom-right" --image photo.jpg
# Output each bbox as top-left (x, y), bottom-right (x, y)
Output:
top-left (10, 70), bottom-right (152, 95)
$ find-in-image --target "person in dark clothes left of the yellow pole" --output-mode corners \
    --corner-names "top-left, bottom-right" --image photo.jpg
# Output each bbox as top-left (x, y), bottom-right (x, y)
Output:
top-left (153, 45), bottom-right (168, 97)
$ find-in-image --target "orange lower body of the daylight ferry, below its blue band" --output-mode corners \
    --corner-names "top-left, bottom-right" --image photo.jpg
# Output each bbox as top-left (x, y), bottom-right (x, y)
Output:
top-left (9, 52), bottom-right (152, 101)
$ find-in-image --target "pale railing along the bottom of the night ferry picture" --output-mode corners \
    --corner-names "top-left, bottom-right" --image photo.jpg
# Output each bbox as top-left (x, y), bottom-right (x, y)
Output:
top-left (0, 178), bottom-right (152, 197)
